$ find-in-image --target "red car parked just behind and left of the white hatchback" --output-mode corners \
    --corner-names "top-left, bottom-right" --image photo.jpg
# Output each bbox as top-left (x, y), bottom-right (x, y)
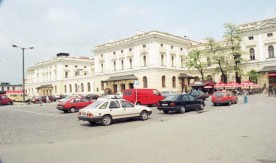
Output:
top-left (57, 98), bottom-right (93, 113)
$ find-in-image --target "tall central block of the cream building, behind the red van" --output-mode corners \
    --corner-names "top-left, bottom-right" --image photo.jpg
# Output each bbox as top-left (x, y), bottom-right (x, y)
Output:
top-left (93, 31), bottom-right (196, 94)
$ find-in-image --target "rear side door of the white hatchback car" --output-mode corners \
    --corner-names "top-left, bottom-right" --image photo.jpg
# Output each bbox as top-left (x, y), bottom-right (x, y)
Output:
top-left (108, 100), bottom-right (126, 119)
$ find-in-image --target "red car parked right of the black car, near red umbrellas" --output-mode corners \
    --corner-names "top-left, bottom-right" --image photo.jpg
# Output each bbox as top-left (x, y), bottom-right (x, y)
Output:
top-left (212, 91), bottom-right (238, 106)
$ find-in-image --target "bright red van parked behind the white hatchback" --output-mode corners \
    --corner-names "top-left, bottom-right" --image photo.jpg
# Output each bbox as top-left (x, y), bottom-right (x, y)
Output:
top-left (123, 89), bottom-right (164, 105)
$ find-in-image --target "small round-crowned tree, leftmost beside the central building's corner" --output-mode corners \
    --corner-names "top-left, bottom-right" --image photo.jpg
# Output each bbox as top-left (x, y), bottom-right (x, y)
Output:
top-left (185, 49), bottom-right (208, 80)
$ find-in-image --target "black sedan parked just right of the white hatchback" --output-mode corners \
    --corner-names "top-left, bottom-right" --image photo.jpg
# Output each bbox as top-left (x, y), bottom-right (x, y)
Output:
top-left (157, 94), bottom-right (205, 114)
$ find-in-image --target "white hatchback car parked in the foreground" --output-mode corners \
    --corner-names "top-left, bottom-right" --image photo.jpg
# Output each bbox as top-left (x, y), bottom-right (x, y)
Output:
top-left (78, 98), bottom-right (152, 126)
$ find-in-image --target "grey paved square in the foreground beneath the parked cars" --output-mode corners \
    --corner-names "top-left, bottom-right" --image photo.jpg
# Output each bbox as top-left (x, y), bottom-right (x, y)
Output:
top-left (0, 94), bottom-right (276, 163)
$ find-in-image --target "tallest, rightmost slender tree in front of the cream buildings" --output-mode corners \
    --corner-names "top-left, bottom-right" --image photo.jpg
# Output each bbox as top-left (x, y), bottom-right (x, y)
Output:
top-left (223, 23), bottom-right (243, 83)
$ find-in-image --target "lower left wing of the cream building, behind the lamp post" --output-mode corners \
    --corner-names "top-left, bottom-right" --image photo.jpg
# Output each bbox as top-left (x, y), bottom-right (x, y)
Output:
top-left (25, 53), bottom-right (94, 96)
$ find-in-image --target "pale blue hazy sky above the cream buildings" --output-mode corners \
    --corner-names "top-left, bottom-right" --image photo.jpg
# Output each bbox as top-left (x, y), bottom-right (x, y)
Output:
top-left (0, 0), bottom-right (276, 84)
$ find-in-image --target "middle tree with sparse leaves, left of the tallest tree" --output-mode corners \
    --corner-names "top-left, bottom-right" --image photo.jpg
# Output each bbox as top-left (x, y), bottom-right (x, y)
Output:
top-left (205, 38), bottom-right (233, 83)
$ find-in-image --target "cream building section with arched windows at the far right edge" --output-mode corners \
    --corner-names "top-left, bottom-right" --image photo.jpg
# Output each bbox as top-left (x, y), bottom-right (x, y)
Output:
top-left (239, 18), bottom-right (276, 88)
